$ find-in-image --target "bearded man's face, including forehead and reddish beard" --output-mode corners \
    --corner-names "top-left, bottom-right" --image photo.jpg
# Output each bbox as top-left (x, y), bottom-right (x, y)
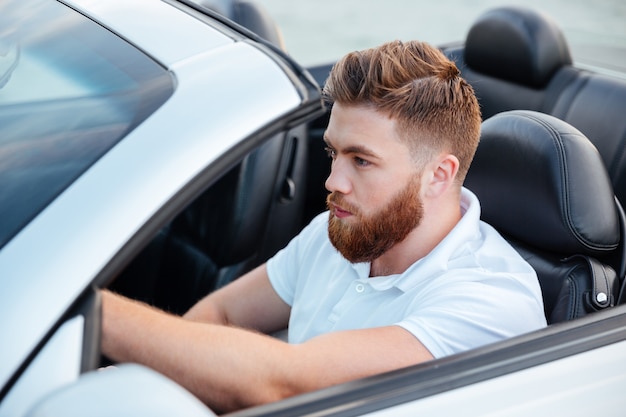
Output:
top-left (325, 104), bottom-right (423, 262)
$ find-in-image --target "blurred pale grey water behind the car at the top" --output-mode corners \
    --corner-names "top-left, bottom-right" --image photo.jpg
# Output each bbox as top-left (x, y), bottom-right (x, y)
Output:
top-left (256, 0), bottom-right (626, 71)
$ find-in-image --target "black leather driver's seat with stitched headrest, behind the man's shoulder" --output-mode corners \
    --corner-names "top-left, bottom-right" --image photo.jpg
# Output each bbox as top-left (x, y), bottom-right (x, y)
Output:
top-left (465, 110), bottom-right (625, 323)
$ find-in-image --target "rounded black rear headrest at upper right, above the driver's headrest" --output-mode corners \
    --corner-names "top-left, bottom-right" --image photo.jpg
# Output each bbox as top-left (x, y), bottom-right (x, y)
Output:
top-left (465, 7), bottom-right (572, 88)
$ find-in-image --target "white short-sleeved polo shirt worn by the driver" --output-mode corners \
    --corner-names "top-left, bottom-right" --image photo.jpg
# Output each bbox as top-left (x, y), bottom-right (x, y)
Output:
top-left (267, 188), bottom-right (546, 357)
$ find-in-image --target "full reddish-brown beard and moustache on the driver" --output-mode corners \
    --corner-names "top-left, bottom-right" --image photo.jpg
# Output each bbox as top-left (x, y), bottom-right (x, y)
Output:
top-left (326, 179), bottom-right (424, 263)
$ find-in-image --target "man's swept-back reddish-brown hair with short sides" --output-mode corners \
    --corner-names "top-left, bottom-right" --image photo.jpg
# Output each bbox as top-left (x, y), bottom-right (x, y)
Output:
top-left (323, 41), bottom-right (481, 184)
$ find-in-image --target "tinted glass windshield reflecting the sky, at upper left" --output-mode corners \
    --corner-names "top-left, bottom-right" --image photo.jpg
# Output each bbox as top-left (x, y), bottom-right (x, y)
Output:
top-left (0, 0), bottom-right (173, 248)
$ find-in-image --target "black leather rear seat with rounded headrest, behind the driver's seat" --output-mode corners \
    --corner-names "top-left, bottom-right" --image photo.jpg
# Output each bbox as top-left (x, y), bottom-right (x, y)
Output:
top-left (443, 7), bottom-right (626, 211)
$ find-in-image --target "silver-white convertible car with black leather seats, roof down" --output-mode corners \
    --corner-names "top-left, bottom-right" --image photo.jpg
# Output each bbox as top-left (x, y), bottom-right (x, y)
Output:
top-left (0, 0), bottom-right (626, 417)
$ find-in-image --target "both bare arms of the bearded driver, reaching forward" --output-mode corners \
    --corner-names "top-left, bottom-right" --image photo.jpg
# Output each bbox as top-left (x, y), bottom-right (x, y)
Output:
top-left (102, 267), bottom-right (432, 412)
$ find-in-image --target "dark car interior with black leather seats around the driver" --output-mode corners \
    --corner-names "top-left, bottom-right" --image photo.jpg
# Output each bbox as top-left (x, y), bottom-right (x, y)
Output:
top-left (111, 0), bottom-right (626, 344)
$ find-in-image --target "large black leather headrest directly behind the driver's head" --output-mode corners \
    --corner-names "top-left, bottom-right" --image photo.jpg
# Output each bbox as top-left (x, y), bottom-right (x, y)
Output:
top-left (465, 110), bottom-right (620, 256)
